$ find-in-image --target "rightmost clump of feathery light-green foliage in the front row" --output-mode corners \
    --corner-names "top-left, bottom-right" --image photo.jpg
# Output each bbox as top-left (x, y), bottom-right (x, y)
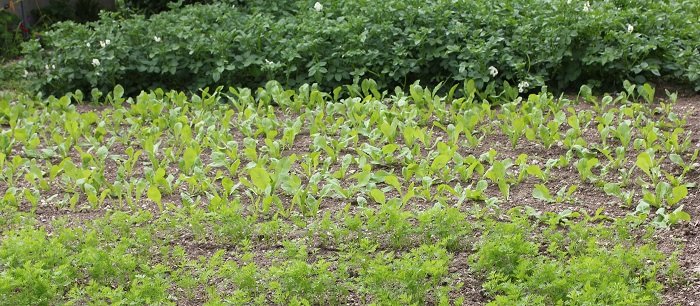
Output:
top-left (474, 216), bottom-right (665, 305)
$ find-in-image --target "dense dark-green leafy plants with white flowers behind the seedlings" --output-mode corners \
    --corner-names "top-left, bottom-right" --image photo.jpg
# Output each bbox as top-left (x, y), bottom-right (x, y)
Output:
top-left (24, 0), bottom-right (700, 93)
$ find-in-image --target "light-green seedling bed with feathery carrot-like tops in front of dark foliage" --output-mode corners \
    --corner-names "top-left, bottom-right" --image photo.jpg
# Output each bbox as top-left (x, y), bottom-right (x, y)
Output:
top-left (0, 80), bottom-right (699, 305)
